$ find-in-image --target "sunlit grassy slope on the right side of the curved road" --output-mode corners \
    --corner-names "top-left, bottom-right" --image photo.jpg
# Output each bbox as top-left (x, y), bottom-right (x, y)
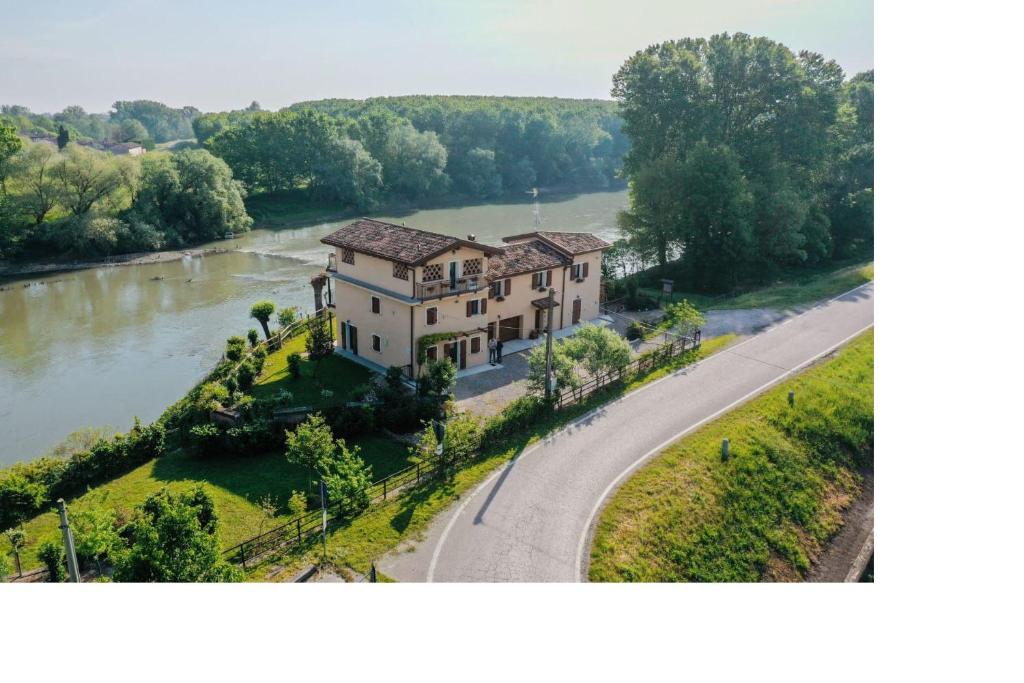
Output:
top-left (590, 332), bottom-right (874, 582)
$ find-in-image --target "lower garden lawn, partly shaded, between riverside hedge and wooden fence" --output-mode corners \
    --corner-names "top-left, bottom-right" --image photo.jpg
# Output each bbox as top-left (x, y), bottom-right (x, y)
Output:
top-left (12, 436), bottom-right (412, 569)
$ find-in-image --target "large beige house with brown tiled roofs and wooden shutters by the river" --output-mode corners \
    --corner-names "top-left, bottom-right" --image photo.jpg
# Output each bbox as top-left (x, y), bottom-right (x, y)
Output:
top-left (321, 218), bottom-right (610, 377)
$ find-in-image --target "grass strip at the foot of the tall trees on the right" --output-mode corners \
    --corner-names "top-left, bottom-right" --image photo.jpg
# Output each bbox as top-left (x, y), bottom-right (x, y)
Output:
top-left (641, 262), bottom-right (874, 310)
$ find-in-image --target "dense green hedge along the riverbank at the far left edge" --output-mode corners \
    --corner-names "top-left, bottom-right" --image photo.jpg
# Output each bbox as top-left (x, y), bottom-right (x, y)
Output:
top-left (0, 420), bottom-right (166, 528)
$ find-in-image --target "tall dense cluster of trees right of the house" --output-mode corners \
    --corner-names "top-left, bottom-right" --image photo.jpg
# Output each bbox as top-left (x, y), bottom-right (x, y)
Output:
top-left (612, 34), bottom-right (873, 291)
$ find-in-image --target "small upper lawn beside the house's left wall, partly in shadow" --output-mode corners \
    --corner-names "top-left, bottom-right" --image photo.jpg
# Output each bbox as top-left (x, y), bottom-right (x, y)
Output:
top-left (252, 334), bottom-right (373, 408)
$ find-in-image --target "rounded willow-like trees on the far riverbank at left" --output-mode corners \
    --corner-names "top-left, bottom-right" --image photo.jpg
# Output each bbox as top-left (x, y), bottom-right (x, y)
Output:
top-left (0, 121), bottom-right (252, 258)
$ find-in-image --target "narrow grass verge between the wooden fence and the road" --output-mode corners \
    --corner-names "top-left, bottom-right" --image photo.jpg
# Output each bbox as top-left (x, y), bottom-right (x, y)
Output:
top-left (250, 335), bottom-right (735, 581)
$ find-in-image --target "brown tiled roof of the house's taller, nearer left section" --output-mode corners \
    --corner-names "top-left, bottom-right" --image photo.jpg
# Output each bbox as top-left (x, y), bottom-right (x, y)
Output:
top-left (321, 218), bottom-right (500, 265)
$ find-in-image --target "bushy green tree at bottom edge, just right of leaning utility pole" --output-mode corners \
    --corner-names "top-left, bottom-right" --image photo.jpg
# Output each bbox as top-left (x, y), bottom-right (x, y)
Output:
top-left (114, 486), bottom-right (241, 583)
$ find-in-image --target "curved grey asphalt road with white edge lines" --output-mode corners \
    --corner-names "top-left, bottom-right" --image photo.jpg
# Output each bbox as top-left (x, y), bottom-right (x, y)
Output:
top-left (380, 283), bottom-right (874, 582)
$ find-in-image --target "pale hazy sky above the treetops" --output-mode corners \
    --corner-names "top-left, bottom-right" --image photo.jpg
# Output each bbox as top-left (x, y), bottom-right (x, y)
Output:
top-left (0, 0), bottom-right (873, 112)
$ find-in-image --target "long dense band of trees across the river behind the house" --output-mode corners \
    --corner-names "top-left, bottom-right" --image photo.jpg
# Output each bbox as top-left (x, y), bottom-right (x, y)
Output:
top-left (193, 96), bottom-right (629, 207)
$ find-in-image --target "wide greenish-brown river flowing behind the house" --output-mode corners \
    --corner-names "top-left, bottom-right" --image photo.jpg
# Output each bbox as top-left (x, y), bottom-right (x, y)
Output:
top-left (0, 191), bottom-right (627, 466)
